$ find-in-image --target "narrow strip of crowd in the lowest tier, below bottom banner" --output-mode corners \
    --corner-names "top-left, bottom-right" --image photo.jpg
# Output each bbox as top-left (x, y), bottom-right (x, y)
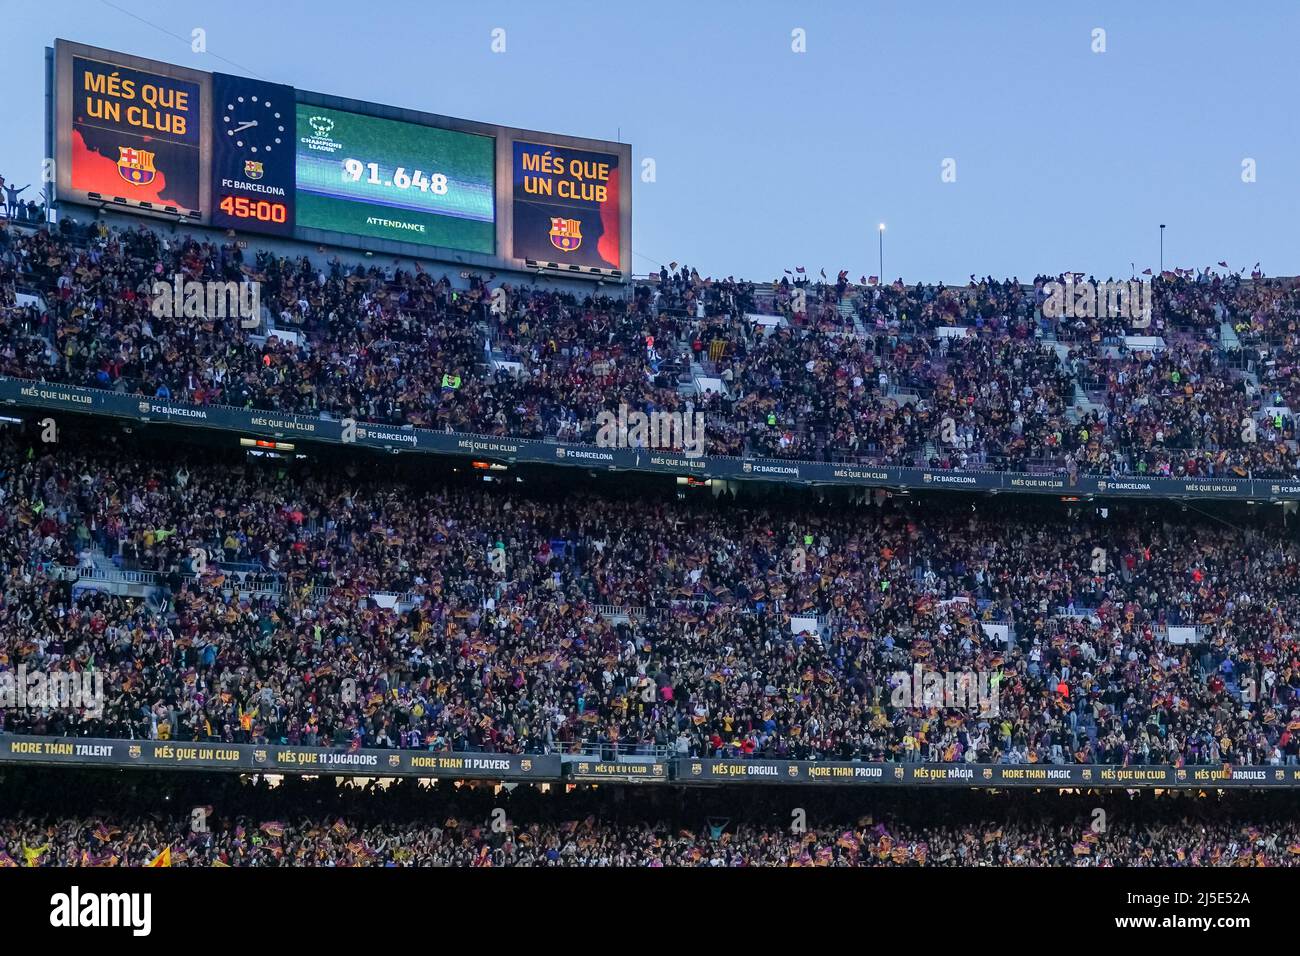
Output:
top-left (0, 773), bottom-right (1300, 868)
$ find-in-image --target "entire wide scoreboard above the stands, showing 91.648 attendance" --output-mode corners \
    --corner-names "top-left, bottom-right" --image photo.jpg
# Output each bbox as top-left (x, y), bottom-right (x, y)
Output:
top-left (49, 39), bottom-right (632, 278)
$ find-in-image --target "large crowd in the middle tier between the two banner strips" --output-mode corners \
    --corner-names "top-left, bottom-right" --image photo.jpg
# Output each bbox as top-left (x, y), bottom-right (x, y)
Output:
top-left (0, 429), bottom-right (1300, 765)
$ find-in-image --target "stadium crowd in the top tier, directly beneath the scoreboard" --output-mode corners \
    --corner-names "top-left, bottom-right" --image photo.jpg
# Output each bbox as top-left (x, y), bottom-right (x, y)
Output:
top-left (0, 213), bottom-right (1300, 477)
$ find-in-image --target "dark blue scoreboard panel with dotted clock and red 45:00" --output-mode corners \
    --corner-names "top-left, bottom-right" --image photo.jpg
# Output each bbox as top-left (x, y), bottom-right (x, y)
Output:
top-left (212, 73), bottom-right (296, 235)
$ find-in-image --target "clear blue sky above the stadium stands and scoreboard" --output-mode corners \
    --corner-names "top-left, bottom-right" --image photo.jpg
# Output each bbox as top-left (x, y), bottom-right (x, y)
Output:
top-left (0, 0), bottom-right (1300, 282)
